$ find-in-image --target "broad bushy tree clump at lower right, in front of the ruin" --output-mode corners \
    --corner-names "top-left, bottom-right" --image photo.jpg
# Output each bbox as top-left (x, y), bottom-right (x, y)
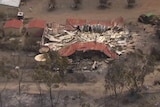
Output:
top-left (105, 50), bottom-right (154, 96)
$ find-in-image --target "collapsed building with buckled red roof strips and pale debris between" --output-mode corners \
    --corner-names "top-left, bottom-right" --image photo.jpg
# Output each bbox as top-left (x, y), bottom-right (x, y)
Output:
top-left (42, 17), bottom-right (135, 58)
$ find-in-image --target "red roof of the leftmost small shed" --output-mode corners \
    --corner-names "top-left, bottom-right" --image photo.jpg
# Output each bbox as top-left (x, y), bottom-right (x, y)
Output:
top-left (4, 19), bottom-right (23, 29)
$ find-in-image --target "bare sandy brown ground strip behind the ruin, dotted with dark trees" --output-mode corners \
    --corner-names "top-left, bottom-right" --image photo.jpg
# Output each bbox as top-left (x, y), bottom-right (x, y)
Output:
top-left (20, 0), bottom-right (160, 23)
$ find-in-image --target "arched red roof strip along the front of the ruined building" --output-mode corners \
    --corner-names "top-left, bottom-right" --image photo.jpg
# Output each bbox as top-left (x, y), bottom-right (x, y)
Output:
top-left (59, 42), bottom-right (117, 59)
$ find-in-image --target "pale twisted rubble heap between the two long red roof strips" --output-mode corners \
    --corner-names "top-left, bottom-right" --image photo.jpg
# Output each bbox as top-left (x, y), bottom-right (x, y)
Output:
top-left (42, 22), bottom-right (135, 55)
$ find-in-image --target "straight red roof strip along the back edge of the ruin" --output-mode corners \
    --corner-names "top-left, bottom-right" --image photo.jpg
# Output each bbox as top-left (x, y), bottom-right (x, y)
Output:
top-left (66, 17), bottom-right (124, 32)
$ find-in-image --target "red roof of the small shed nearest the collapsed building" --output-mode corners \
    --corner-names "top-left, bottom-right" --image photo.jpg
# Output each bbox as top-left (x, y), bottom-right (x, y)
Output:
top-left (28, 20), bottom-right (46, 28)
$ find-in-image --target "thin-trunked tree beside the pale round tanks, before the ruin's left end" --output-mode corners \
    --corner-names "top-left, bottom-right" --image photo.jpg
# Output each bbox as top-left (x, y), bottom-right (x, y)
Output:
top-left (33, 51), bottom-right (68, 107)
